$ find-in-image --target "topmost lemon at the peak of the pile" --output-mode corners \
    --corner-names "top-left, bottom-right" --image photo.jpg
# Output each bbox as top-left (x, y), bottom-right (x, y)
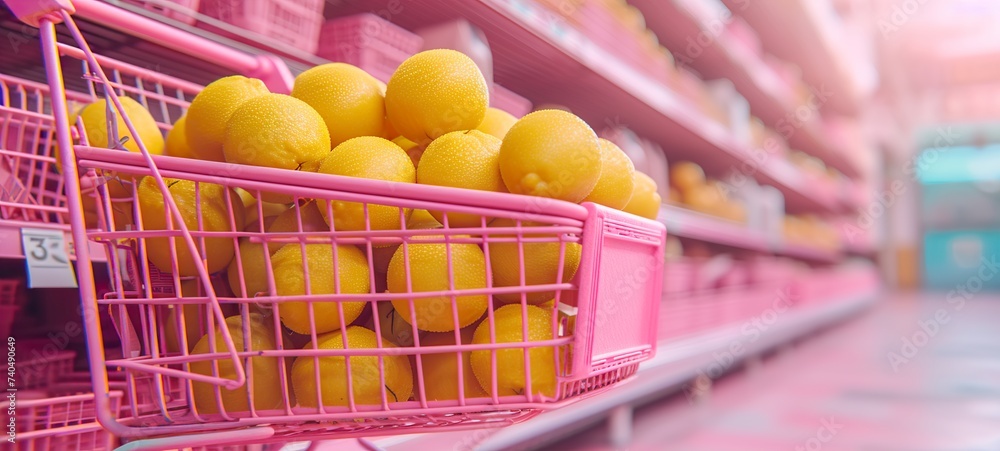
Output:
top-left (385, 49), bottom-right (489, 144)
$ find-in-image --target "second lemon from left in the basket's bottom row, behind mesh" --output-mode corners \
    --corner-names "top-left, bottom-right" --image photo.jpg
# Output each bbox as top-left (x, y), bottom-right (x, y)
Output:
top-left (292, 326), bottom-right (413, 407)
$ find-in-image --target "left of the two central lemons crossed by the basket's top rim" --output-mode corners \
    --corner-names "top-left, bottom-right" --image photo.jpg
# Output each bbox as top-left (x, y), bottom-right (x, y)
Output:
top-left (319, 136), bottom-right (416, 230)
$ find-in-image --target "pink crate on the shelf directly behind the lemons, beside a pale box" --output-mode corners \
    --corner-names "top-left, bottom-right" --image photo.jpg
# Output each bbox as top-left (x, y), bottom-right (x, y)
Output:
top-left (316, 13), bottom-right (423, 82)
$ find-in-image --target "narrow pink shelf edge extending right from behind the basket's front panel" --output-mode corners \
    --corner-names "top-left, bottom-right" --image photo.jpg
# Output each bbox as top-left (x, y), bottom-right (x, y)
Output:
top-left (658, 205), bottom-right (842, 263)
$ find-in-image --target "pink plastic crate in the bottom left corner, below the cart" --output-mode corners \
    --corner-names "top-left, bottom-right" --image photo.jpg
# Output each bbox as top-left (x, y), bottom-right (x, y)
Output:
top-left (3, 391), bottom-right (122, 451)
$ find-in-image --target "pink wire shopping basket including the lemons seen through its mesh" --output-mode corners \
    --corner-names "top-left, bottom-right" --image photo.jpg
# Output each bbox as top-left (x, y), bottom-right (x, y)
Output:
top-left (23, 3), bottom-right (665, 442)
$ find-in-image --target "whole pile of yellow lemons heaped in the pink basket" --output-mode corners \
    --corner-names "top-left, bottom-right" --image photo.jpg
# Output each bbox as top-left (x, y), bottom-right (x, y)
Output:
top-left (78, 50), bottom-right (660, 413)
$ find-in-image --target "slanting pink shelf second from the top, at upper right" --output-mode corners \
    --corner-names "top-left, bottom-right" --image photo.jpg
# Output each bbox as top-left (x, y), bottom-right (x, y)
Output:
top-left (630, 0), bottom-right (858, 177)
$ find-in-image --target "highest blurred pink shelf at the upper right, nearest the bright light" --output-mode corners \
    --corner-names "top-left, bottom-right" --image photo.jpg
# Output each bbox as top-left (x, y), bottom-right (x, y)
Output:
top-left (722, 0), bottom-right (862, 115)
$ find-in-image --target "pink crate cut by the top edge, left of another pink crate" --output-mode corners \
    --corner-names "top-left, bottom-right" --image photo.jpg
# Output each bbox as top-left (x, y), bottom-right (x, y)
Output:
top-left (195, 0), bottom-right (324, 53)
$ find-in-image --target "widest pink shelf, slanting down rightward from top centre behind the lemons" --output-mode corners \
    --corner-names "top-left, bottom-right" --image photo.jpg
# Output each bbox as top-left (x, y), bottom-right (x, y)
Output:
top-left (327, 0), bottom-right (839, 212)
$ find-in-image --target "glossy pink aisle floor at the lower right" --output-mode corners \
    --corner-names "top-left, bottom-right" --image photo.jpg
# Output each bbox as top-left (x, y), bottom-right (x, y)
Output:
top-left (553, 294), bottom-right (1000, 451)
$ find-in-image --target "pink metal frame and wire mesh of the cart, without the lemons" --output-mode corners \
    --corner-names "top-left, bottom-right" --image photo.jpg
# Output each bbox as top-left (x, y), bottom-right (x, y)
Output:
top-left (12, 1), bottom-right (665, 445)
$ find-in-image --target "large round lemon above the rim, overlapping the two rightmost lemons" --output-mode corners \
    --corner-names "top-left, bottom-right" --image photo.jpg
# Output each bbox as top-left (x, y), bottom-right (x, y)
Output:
top-left (500, 110), bottom-right (601, 202)
